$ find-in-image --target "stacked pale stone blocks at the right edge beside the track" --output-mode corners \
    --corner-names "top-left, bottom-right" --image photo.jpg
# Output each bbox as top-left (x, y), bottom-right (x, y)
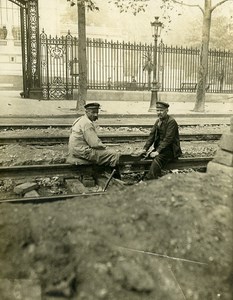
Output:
top-left (207, 117), bottom-right (233, 179)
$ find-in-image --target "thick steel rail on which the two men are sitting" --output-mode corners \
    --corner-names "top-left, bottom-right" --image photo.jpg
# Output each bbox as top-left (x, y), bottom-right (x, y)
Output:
top-left (0, 156), bottom-right (213, 178)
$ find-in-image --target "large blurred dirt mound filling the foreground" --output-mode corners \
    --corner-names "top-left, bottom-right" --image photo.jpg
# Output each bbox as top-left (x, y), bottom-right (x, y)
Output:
top-left (0, 173), bottom-right (233, 300)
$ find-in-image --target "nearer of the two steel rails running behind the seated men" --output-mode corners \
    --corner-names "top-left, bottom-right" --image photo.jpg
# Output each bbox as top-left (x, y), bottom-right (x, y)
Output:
top-left (0, 133), bottom-right (221, 145)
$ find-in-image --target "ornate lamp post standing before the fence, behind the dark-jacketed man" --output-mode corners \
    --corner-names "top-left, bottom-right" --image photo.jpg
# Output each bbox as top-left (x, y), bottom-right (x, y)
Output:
top-left (149, 17), bottom-right (163, 111)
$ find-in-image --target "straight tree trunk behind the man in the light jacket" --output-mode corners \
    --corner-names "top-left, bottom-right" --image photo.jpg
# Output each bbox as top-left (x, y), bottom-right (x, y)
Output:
top-left (76, 2), bottom-right (87, 111)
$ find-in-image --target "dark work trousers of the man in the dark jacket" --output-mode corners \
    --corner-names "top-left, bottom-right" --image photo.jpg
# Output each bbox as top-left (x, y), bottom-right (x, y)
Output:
top-left (144, 148), bottom-right (174, 180)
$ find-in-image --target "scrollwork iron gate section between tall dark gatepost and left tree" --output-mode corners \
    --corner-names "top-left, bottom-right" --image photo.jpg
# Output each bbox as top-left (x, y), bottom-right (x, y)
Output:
top-left (40, 32), bottom-right (75, 99)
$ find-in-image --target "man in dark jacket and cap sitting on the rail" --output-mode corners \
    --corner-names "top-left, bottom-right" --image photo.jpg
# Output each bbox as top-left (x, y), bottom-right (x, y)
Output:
top-left (142, 101), bottom-right (182, 180)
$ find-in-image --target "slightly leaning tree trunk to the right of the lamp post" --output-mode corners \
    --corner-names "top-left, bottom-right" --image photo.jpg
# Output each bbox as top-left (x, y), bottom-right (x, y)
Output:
top-left (194, 0), bottom-right (211, 112)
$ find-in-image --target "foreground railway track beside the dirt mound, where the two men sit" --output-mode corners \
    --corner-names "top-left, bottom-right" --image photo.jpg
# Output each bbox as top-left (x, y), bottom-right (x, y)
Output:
top-left (0, 155), bottom-right (212, 203)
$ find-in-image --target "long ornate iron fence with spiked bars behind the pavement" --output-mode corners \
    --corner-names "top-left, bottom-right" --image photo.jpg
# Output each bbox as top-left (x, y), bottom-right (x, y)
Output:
top-left (40, 32), bottom-right (233, 99)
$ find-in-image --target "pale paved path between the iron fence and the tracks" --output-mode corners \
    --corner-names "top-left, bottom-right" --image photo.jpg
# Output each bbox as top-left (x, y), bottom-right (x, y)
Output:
top-left (0, 91), bottom-right (233, 118)
